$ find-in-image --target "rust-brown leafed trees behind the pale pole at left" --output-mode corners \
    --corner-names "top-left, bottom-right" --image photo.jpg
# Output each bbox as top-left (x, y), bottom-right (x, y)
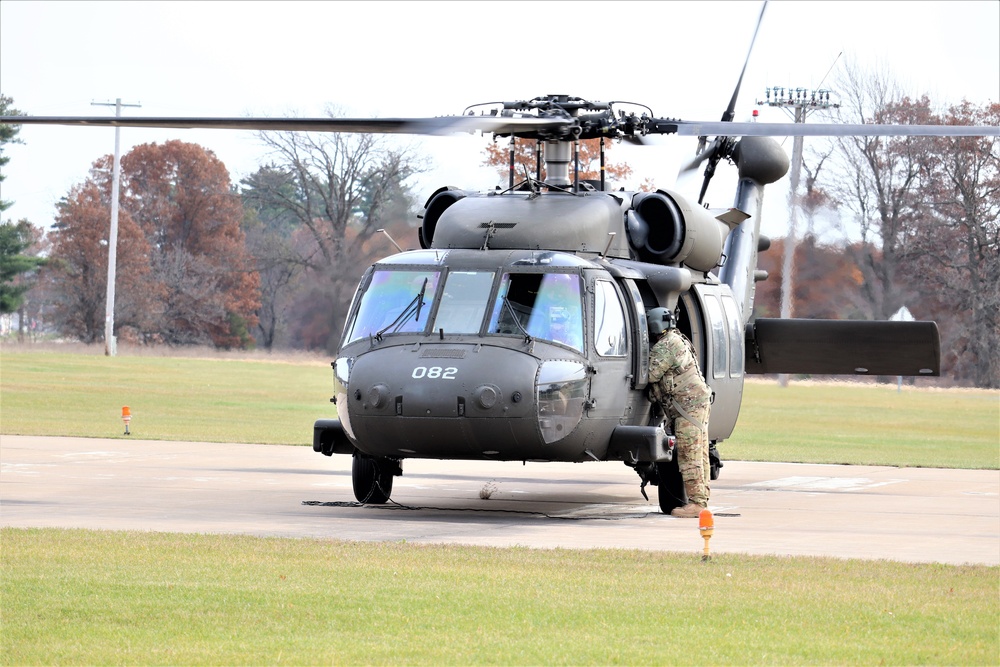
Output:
top-left (50, 141), bottom-right (259, 348)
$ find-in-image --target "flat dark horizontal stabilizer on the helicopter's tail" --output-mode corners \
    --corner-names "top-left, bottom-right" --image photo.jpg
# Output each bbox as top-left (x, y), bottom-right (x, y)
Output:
top-left (746, 319), bottom-right (941, 375)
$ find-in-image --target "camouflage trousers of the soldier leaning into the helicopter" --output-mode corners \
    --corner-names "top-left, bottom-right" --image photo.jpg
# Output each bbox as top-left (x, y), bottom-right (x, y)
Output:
top-left (663, 385), bottom-right (712, 507)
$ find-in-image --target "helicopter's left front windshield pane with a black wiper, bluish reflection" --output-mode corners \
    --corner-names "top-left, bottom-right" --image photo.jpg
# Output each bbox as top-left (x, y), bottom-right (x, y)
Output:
top-left (347, 270), bottom-right (441, 343)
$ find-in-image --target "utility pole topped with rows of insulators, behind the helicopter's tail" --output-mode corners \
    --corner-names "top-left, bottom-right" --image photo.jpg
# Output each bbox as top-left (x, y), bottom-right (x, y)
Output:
top-left (757, 86), bottom-right (840, 387)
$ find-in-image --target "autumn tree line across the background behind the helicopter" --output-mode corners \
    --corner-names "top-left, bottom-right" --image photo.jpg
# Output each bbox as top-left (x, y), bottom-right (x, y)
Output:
top-left (0, 69), bottom-right (1000, 387)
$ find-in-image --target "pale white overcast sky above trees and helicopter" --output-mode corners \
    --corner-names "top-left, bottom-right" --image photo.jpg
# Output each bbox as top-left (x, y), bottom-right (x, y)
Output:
top-left (0, 0), bottom-right (1000, 240)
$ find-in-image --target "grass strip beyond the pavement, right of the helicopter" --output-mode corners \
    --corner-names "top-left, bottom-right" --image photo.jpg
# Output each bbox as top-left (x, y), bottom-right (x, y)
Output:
top-left (720, 380), bottom-right (1000, 469)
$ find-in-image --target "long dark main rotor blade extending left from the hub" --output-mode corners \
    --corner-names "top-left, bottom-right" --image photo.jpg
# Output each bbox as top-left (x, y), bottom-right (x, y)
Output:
top-left (0, 116), bottom-right (572, 135)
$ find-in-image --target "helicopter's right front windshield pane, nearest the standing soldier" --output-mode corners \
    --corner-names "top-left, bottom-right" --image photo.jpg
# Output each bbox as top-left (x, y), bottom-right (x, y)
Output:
top-left (488, 273), bottom-right (583, 352)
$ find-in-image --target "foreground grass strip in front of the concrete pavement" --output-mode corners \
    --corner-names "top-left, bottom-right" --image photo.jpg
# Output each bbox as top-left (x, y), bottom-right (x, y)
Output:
top-left (0, 529), bottom-right (1000, 665)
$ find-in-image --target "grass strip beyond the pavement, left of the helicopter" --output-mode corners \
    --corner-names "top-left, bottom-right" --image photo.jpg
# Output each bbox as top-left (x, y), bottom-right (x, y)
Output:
top-left (0, 347), bottom-right (336, 445)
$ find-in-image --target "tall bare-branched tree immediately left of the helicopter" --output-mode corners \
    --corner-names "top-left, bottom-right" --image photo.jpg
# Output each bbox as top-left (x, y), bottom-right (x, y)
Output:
top-left (250, 113), bottom-right (420, 350)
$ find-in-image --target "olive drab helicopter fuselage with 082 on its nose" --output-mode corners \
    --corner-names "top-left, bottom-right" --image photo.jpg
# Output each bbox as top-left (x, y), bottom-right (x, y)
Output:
top-left (316, 189), bottom-right (768, 472)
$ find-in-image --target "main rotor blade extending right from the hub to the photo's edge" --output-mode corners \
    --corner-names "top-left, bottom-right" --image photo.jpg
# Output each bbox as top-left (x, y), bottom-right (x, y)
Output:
top-left (660, 120), bottom-right (1000, 137)
